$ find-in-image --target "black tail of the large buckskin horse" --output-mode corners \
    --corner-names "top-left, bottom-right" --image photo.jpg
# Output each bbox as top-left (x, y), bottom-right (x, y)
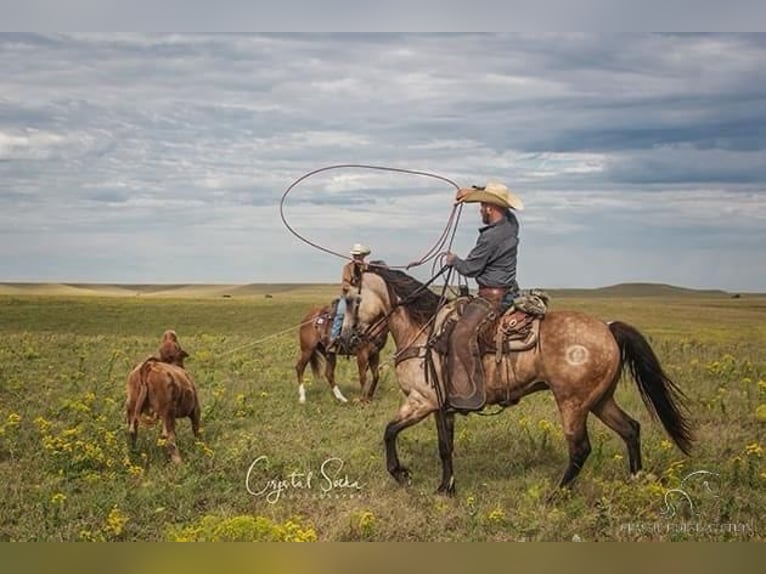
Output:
top-left (609, 321), bottom-right (694, 455)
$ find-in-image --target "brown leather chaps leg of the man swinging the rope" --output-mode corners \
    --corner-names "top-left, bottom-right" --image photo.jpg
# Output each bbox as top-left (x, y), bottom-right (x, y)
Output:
top-left (447, 297), bottom-right (493, 411)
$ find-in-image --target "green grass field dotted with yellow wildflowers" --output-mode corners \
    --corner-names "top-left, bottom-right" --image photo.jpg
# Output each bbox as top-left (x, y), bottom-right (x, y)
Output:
top-left (0, 285), bottom-right (766, 541)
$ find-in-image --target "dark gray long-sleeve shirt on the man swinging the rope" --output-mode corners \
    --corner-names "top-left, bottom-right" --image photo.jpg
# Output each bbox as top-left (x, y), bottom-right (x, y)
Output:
top-left (452, 210), bottom-right (519, 291)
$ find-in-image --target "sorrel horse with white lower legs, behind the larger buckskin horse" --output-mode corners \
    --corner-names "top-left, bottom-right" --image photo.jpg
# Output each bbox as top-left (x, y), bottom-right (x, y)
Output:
top-left (295, 305), bottom-right (388, 403)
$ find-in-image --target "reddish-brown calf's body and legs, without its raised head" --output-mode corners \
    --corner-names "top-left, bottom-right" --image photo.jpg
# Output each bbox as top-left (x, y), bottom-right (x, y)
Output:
top-left (125, 357), bottom-right (200, 463)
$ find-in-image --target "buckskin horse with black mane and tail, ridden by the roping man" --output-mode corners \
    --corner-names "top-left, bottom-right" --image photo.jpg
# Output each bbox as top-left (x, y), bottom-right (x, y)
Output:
top-left (343, 266), bottom-right (693, 495)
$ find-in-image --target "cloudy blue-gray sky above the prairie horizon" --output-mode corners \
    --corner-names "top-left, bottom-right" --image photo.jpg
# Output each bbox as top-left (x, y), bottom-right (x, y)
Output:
top-left (0, 33), bottom-right (766, 292)
